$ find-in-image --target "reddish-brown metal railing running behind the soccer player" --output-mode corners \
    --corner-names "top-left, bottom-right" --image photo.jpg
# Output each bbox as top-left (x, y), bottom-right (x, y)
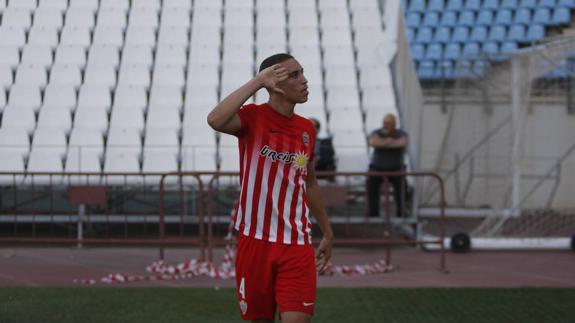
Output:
top-left (0, 172), bottom-right (446, 270)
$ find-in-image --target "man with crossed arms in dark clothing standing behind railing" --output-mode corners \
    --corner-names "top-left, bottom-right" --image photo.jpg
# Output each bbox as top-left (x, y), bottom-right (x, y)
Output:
top-left (367, 114), bottom-right (407, 217)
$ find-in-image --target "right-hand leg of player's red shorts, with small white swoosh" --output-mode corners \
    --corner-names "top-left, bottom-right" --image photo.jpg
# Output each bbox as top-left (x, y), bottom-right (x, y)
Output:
top-left (275, 245), bottom-right (317, 315)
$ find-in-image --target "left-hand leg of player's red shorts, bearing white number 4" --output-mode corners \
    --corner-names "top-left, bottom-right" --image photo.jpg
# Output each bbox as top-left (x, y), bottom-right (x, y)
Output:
top-left (236, 237), bottom-right (276, 320)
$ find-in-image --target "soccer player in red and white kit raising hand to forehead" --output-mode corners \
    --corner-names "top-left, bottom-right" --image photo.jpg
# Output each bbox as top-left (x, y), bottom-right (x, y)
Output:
top-left (208, 54), bottom-right (333, 323)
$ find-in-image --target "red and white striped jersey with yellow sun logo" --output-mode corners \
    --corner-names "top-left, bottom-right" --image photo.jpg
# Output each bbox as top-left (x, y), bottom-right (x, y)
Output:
top-left (235, 104), bottom-right (315, 245)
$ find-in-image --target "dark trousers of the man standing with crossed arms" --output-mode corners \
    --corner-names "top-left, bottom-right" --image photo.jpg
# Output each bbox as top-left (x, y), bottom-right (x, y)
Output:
top-left (367, 166), bottom-right (407, 217)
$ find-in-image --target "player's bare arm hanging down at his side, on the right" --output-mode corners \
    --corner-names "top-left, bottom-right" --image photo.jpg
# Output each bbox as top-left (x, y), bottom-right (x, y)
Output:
top-left (306, 163), bottom-right (333, 272)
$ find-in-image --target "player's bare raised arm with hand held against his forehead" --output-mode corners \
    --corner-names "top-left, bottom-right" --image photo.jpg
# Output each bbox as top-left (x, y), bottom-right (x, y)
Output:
top-left (208, 64), bottom-right (287, 135)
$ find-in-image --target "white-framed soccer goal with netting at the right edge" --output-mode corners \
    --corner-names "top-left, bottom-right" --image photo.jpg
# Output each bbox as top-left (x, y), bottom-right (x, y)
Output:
top-left (420, 36), bottom-right (575, 253)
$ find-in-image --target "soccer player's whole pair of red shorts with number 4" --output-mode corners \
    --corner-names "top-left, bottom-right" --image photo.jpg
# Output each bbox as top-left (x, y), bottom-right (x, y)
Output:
top-left (236, 234), bottom-right (317, 320)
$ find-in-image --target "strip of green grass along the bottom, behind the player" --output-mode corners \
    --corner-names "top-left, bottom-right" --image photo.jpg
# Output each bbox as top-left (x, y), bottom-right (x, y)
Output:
top-left (0, 288), bottom-right (575, 323)
